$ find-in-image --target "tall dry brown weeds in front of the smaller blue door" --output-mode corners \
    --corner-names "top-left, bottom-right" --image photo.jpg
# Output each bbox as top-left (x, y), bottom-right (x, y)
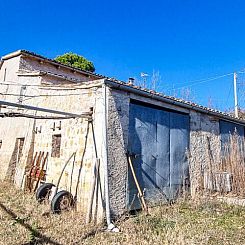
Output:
top-left (200, 133), bottom-right (245, 197)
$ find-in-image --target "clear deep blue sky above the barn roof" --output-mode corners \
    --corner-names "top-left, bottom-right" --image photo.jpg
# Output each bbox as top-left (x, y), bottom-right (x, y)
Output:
top-left (0, 0), bottom-right (245, 109)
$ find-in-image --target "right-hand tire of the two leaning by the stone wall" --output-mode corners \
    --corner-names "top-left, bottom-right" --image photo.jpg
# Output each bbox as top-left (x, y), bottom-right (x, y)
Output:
top-left (51, 191), bottom-right (74, 214)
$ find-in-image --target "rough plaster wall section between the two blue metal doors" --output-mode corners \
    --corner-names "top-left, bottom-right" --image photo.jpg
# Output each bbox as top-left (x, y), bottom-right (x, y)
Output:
top-left (189, 111), bottom-right (221, 197)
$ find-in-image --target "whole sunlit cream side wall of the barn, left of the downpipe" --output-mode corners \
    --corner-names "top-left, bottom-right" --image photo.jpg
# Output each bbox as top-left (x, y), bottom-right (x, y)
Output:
top-left (0, 57), bottom-right (104, 220)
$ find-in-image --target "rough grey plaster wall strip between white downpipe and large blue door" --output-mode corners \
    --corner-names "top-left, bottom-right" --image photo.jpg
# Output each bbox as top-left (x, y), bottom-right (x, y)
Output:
top-left (108, 87), bottom-right (130, 216)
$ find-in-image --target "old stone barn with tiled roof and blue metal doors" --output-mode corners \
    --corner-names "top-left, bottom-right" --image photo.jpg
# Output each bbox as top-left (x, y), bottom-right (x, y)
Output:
top-left (0, 50), bottom-right (245, 224)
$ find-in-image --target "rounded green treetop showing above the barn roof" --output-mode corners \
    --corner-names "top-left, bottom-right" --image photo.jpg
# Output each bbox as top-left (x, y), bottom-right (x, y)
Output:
top-left (55, 52), bottom-right (95, 72)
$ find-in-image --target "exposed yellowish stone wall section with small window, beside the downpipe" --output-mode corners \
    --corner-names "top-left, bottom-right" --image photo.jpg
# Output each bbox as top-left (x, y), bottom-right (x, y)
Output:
top-left (25, 84), bottom-right (103, 217)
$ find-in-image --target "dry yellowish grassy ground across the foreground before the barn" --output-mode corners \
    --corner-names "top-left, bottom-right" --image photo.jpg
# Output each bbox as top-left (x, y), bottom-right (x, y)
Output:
top-left (0, 182), bottom-right (245, 245)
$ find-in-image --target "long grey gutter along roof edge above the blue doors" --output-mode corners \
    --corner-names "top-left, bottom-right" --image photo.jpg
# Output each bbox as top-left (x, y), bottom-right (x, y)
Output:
top-left (105, 80), bottom-right (245, 126)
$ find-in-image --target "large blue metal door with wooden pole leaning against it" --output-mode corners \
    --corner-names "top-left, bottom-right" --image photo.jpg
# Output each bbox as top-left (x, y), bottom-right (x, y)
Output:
top-left (128, 103), bottom-right (189, 209)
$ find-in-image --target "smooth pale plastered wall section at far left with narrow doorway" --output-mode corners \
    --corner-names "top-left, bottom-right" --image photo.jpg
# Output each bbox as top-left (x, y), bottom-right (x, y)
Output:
top-left (0, 57), bottom-right (38, 184)
